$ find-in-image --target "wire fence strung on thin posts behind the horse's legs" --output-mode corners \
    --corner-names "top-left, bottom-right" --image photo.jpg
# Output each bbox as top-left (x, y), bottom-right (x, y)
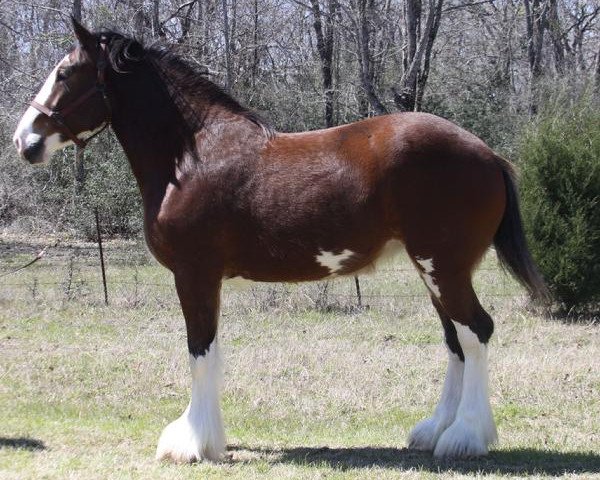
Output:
top-left (0, 240), bottom-right (522, 311)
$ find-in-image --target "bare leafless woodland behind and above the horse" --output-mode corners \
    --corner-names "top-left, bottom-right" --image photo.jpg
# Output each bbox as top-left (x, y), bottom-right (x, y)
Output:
top-left (0, 0), bottom-right (600, 237)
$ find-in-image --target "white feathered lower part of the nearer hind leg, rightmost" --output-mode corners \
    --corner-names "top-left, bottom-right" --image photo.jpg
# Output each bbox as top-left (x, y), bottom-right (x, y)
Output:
top-left (433, 321), bottom-right (498, 457)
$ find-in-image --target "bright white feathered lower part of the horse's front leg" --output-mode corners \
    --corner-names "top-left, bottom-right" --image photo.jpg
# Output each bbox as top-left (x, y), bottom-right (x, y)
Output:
top-left (156, 339), bottom-right (225, 463)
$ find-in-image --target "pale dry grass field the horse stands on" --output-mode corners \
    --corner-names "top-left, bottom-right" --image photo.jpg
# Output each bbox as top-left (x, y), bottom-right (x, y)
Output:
top-left (0, 236), bottom-right (600, 480)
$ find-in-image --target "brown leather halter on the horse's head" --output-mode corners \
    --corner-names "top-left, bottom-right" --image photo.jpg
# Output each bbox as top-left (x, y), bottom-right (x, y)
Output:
top-left (30, 42), bottom-right (112, 150)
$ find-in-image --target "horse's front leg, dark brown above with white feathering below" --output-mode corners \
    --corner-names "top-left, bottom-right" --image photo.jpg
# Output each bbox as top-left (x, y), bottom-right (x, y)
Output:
top-left (156, 268), bottom-right (225, 463)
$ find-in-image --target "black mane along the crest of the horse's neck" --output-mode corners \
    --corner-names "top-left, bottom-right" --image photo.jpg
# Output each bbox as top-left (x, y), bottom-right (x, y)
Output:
top-left (96, 30), bottom-right (274, 147)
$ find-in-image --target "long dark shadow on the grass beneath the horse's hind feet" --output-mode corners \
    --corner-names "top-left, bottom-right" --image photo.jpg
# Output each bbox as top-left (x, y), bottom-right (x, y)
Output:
top-left (229, 445), bottom-right (600, 475)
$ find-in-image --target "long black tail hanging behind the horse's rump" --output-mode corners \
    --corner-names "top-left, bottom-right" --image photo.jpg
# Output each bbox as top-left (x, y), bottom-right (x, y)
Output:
top-left (494, 157), bottom-right (550, 301)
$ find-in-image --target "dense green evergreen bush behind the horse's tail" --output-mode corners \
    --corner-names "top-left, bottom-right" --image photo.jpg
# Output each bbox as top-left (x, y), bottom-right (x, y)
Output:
top-left (520, 96), bottom-right (600, 309)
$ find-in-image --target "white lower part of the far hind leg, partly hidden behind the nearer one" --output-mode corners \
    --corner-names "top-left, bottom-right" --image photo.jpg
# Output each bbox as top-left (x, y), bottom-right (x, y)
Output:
top-left (408, 349), bottom-right (465, 451)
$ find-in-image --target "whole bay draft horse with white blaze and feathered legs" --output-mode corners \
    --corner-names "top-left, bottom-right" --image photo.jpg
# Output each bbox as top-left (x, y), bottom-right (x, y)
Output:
top-left (14, 21), bottom-right (545, 462)
